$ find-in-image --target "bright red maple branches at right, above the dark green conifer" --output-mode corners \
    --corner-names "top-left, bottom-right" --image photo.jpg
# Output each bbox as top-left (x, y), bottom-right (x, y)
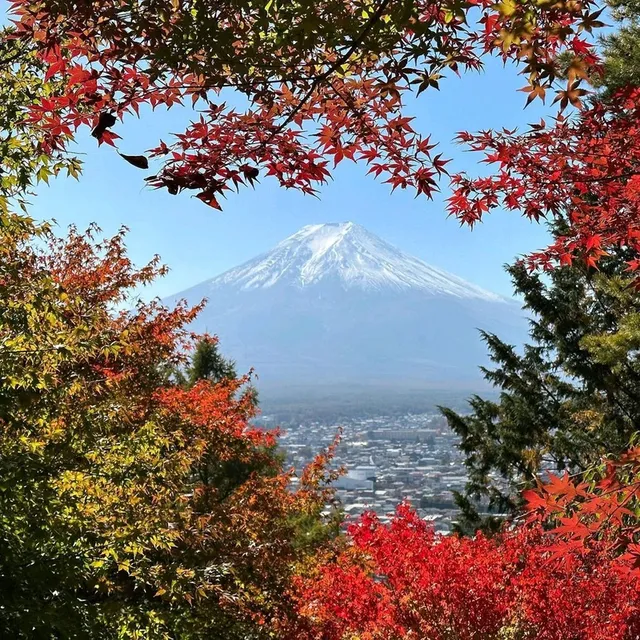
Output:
top-left (449, 87), bottom-right (640, 270)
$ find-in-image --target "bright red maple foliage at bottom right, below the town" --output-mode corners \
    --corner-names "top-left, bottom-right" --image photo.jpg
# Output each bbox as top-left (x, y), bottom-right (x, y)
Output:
top-left (294, 505), bottom-right (640, 640)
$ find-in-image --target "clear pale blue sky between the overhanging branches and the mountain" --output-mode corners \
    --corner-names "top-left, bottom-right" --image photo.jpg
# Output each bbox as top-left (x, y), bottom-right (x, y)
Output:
top-left (27, 53), bottom-right (551, 297)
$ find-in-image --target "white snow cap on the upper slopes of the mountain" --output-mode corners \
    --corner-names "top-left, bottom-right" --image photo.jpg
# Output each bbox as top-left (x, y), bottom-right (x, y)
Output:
top-left (207, 222), bottom-right (503, 302)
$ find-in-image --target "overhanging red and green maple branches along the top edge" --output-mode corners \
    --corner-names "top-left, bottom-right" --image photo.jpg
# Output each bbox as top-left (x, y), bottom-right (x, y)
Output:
top-left (4, 0), bottom-right (601, 207)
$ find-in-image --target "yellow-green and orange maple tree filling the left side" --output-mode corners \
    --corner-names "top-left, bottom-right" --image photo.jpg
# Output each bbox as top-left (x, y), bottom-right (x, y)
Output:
top-left (0, 214), bottom-right (338, 638)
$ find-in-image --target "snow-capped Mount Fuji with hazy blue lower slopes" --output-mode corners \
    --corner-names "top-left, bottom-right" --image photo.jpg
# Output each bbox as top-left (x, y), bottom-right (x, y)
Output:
top-left (165, 222), bottom-right (526, 387)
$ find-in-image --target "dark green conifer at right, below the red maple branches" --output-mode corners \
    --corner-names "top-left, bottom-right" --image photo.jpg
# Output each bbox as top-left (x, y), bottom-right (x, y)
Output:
top-left (442, 249), bottom-right (640, 533)
